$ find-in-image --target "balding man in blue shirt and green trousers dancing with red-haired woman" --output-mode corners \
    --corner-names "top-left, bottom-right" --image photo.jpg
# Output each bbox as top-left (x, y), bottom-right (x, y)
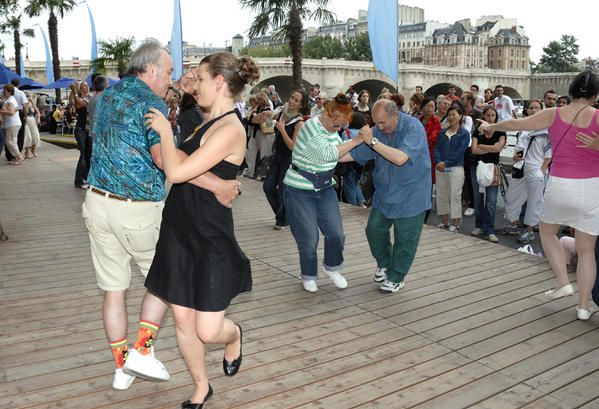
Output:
top-left (341, 99), bottom-right (432, 293)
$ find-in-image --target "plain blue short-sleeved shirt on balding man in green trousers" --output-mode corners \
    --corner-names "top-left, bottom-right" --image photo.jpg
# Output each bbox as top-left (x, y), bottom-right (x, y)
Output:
top-left (351, 112), bottom-right (432, 219)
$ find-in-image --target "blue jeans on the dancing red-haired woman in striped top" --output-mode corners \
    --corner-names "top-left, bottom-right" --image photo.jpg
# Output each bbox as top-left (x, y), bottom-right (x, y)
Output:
top-left (283, 185), bottom-right (345, 280)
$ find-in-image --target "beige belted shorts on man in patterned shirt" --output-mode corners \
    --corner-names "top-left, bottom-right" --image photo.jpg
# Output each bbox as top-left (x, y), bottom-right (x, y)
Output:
top-left (81, 191), bottom-right (164, 291)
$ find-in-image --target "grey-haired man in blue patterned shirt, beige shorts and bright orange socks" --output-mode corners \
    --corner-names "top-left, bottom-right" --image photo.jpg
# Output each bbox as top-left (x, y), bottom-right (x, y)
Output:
top-left (82, 40), bottom-right (238, 390)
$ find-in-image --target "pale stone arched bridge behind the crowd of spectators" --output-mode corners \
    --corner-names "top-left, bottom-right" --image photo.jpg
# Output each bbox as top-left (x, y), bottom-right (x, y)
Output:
top-left (16, 58), bottom-right (576, 100)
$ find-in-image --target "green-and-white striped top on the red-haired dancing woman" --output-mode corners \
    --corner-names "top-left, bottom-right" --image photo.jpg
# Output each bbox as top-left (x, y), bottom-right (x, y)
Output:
top-left (283, 117), bottom-right (341, 190)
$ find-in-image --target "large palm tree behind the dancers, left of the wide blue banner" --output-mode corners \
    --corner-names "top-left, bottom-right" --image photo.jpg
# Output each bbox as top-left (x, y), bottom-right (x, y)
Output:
top-left (239, 0), bottom-right (335, 89)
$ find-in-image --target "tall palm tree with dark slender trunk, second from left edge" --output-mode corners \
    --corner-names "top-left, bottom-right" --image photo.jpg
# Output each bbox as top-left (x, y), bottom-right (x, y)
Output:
top-left (25, 0), bottom-right (76, 101)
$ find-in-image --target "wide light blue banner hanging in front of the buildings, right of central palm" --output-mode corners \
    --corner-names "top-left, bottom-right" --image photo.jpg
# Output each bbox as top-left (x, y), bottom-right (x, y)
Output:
top-left (368, 0), bottom-right (399, 84)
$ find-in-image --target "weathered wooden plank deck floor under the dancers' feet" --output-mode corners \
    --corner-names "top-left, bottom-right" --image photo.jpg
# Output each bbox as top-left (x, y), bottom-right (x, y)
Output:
top-left (0, 144), bottom-right (599, 409)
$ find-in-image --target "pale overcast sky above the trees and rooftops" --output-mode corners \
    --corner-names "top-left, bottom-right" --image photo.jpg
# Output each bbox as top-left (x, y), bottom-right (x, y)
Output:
top-left (0, 0), bottom-right (599, 62)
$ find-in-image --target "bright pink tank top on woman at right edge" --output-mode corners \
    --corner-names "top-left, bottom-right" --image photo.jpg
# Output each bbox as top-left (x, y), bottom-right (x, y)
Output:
top-left (549, 108), bottom-right (599, 179)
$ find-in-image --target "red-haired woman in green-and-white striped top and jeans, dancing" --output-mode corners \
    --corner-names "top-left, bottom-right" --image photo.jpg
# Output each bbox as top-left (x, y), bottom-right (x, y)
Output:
top-left (283, 94), bottom-right (363, 293)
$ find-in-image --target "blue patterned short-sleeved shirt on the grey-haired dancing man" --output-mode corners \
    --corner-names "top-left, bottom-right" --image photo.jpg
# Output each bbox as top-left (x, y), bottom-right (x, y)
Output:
top-left (88, 76), bottom-right (167, 202)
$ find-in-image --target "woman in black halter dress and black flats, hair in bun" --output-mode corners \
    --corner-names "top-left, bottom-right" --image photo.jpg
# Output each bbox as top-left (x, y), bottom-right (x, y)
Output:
top-left (146, 53), bottom-right (259, 408)
